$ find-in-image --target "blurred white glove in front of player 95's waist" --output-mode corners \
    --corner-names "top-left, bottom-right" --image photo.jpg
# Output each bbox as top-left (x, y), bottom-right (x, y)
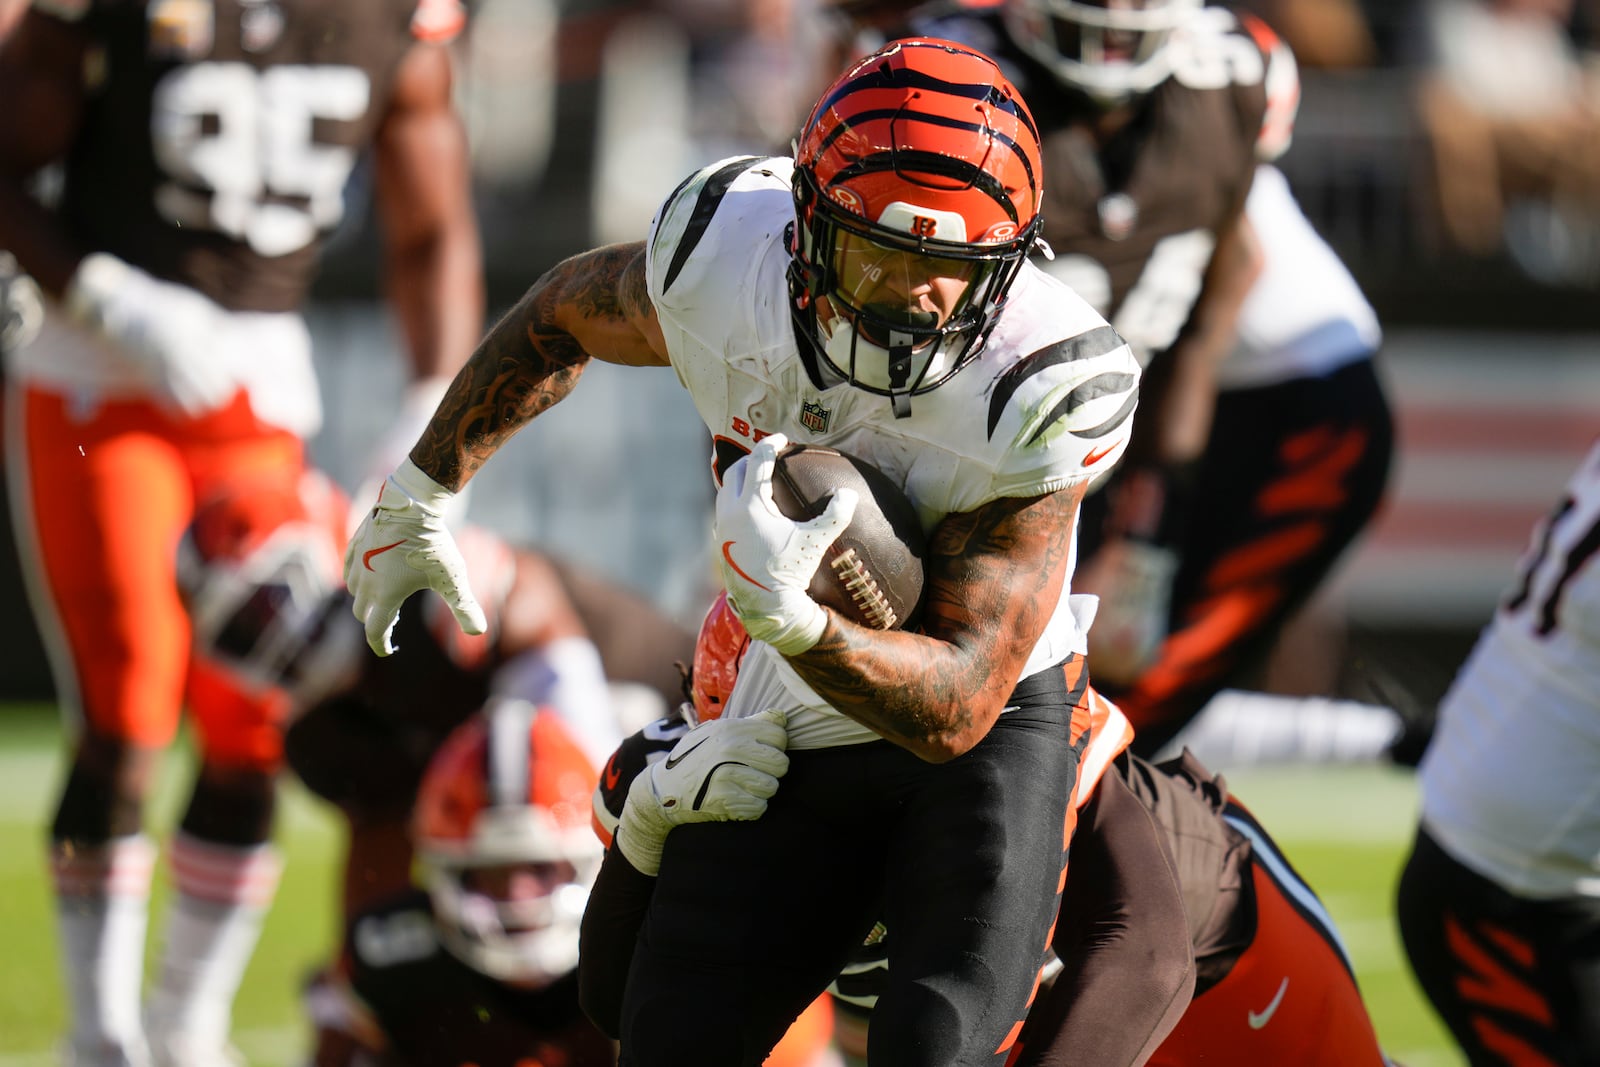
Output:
top-left (62, 253), bottom-right (238, 416)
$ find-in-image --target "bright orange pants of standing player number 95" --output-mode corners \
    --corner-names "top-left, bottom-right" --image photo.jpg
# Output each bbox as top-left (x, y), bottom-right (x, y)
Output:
top-left (6, 384), bottom-right (304, 769)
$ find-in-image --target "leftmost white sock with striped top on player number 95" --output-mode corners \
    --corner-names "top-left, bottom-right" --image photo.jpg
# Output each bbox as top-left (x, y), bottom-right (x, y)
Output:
top-left (51, 833), bottom-right (155, 1067)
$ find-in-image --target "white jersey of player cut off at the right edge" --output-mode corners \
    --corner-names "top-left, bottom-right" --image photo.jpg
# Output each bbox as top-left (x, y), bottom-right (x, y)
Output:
top-left (1421, 442), bottom-right (1600, 897)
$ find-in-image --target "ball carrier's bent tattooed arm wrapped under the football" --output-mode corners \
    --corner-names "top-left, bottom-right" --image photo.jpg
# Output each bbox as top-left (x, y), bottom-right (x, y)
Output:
top-left (789, 485), bottom-right (1085, 763)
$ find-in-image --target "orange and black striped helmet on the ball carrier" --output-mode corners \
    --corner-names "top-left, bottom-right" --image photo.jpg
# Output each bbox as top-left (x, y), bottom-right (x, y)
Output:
top-left (789, 37), bottom-right (1042, 414)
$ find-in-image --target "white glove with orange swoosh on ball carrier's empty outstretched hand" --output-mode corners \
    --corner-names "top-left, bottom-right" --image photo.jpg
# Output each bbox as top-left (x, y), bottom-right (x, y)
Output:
top-left (344, 459), bottom-right (488, 656)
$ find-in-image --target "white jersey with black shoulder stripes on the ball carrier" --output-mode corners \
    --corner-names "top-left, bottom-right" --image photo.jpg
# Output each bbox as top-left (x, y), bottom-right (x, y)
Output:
top-left (648, 157), bottom-right (1139, 749)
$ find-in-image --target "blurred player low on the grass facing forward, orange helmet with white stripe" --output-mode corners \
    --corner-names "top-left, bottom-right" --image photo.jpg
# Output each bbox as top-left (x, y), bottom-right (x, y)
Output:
top-left (310, 699), bottom-right (616, 1067)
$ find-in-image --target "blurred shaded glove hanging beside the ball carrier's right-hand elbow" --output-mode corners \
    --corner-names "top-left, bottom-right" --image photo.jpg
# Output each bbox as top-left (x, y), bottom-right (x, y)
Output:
top-left (1074, 539), bottom-right (1178, 686)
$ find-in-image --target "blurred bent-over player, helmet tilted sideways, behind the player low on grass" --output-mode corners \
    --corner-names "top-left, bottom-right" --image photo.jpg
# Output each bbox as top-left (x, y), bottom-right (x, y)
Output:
top-left (178, 472), bottom-right (693, 1062)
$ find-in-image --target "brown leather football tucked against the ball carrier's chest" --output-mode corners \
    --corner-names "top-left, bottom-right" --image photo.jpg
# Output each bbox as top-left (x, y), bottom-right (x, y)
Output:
top-left (773, 445), bottom-right (925, 630)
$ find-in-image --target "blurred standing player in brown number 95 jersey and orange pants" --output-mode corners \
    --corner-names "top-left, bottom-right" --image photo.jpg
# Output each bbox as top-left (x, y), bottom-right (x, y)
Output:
top-left (0, 0), bottom-right (483, 1064)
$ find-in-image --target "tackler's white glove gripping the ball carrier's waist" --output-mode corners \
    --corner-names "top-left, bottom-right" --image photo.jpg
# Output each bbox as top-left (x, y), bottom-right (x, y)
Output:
top-left (616, 709), bottom-right (789, 877)
